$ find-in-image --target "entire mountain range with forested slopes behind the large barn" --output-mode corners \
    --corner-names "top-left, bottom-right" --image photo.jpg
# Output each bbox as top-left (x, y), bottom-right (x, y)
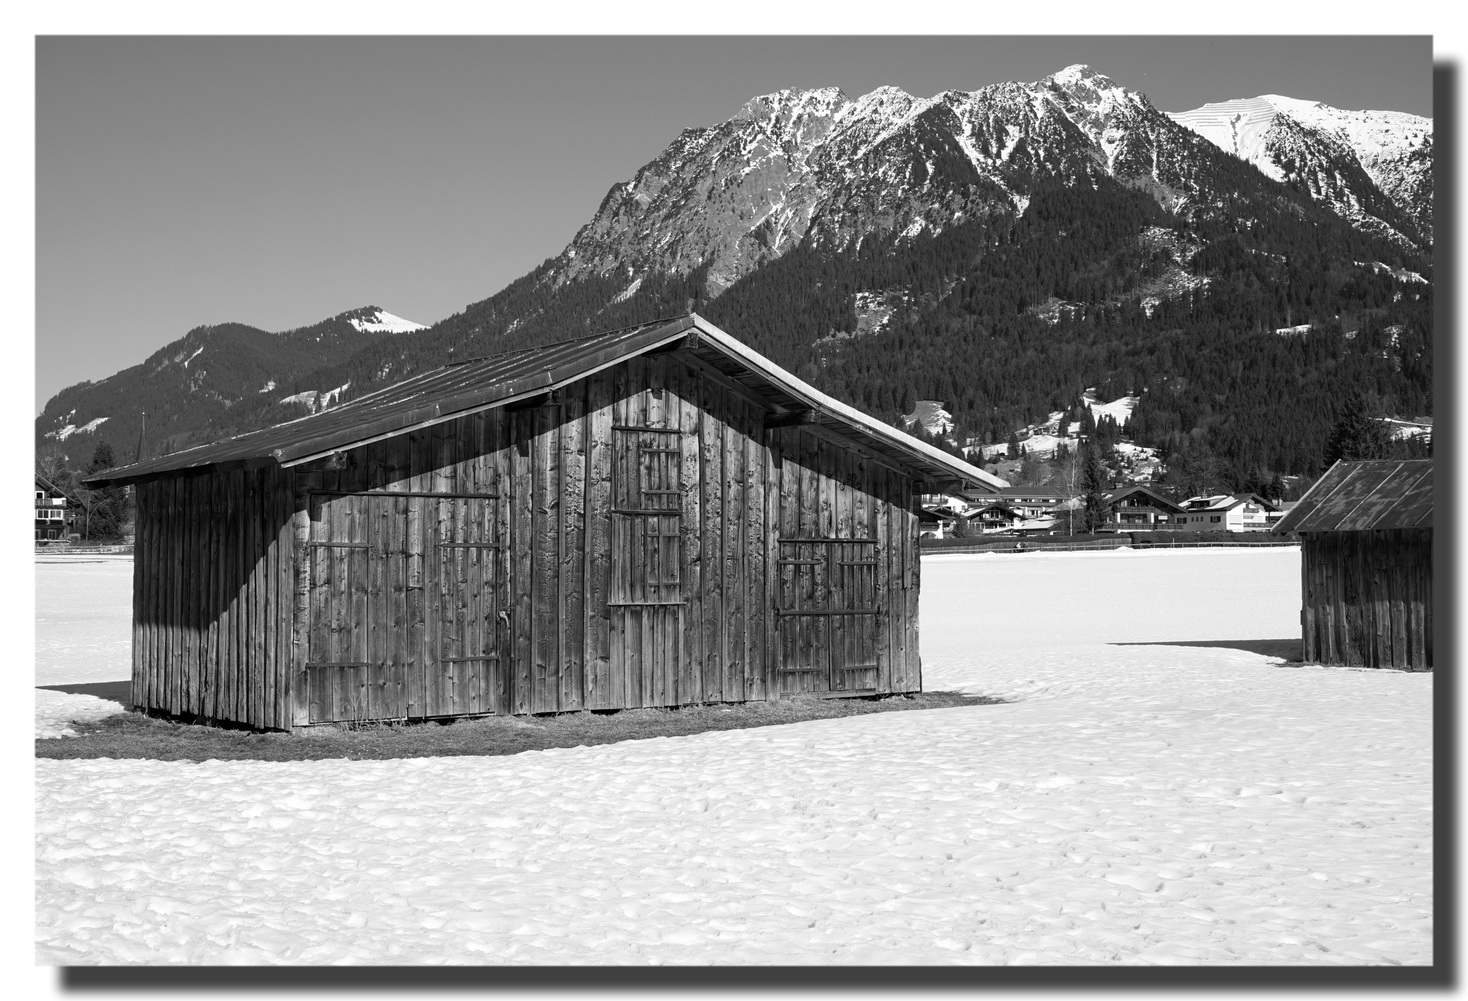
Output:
top-left (37, 66), bottom-right (1433, 490)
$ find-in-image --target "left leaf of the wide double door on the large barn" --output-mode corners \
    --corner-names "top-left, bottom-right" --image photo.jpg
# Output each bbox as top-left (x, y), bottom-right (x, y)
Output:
top-left (305, 492), bottom-right (408, 724)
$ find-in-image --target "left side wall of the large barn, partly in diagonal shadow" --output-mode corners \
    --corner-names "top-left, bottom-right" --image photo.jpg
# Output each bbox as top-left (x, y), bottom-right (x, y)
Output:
top-left (132, 468), bottom-right (294, 728)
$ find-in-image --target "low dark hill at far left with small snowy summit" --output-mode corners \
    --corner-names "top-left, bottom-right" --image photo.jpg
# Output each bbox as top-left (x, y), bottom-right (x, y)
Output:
top-left (35, 305), bottom-right (424, 464)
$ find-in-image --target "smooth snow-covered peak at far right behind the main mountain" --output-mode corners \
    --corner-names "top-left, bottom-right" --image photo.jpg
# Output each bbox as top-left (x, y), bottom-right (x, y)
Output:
top-left (1171, 94), bottom-right (1433, 245)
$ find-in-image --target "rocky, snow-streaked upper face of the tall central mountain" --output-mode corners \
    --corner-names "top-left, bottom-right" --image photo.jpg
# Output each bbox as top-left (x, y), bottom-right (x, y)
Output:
top-left (545, 65), bottom-right (1268, 295)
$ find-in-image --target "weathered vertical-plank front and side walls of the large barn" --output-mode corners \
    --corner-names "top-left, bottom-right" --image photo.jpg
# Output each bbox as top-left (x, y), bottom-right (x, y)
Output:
top-left (134, 344), bottom-right (920, 728)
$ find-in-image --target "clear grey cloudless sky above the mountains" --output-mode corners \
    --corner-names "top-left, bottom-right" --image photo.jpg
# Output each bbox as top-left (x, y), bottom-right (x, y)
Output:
top-left (34, 35), bottom-right (1433, 412)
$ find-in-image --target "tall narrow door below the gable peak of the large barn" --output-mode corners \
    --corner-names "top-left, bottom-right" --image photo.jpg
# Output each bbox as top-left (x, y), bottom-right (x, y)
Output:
top-left (608, 427), bottom-right (684, 706)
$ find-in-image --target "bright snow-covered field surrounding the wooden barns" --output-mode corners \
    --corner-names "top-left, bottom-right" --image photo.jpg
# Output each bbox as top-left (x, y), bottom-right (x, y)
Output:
top-left (35, 549), bottom-right (1433, 964)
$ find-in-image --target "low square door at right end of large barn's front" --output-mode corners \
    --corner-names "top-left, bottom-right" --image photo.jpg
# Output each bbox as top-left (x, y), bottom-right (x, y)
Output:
top-left (775, 539), bottom-right (881, 694)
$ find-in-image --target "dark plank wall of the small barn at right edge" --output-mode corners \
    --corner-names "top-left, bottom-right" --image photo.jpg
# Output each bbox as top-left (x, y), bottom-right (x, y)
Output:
top-left (1301, 528), bottom-right (1433, 671)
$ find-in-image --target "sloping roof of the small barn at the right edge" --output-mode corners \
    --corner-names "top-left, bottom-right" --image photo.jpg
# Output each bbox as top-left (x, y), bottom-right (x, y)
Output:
top-left (1273, 459), bottom-right (1433, 533)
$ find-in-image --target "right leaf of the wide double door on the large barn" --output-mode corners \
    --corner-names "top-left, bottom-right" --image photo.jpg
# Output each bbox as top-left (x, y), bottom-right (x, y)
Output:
top-left (423, 496), bottom-right (509, 716)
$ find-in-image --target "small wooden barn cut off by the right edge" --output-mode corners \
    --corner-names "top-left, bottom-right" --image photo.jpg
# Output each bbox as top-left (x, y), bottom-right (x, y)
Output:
top-left (1273, 459), bottom-right (1433, 671)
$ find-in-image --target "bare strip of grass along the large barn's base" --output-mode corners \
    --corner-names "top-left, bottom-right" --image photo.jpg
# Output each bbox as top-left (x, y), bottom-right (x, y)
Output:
top-left (35, 691), bottom-right (1003, 762)
